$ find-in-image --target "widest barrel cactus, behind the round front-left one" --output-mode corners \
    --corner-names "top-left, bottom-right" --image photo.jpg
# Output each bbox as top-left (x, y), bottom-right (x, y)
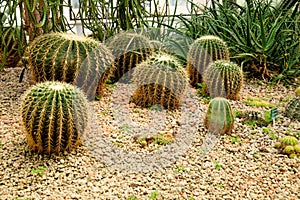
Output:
top-left (25, 33), bottom-right (114, 100)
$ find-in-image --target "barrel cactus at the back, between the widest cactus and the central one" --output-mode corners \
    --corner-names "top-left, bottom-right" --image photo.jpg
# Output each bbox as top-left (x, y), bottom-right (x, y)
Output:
top-left (108, 32), bottom-right (153, 81)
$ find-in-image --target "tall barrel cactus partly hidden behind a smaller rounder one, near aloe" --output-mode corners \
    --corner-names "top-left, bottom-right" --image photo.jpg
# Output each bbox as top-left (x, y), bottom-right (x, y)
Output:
top-left (187, 35), bottom-right (229, 86)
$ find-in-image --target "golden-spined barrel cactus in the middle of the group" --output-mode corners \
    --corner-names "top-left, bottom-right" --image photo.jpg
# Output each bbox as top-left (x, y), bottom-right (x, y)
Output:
top-left (132, 52), bottom-right (188, 110)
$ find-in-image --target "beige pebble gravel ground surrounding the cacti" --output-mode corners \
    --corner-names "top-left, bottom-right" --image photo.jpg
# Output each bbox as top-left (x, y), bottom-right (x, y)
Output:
top-left (0, 68), bottom-right (300, 199)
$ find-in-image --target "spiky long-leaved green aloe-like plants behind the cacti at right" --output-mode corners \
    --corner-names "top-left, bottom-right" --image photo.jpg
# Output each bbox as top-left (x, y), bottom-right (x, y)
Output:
top-left (180, 0), bottom-right (300, 81)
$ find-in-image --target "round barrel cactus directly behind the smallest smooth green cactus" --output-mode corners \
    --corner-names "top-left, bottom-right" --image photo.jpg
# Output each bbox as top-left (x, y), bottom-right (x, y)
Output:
top-left (204, 60), bottom-right (243, 100)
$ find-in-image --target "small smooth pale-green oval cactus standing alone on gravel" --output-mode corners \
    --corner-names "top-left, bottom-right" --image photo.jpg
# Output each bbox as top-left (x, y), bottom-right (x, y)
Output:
top-left (204, 97), bottom-right (234, 135)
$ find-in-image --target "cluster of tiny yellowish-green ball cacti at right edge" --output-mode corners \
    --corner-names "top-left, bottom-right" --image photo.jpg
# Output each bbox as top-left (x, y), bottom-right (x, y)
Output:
top-left (274, 136), bottom-right (300, 158)
